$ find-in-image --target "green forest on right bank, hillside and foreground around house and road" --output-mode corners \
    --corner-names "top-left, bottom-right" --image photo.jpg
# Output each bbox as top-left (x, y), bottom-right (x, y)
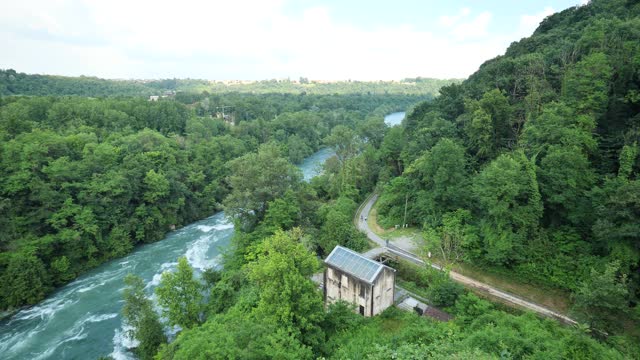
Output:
top-left (116, 1), bottom-right (640, 359)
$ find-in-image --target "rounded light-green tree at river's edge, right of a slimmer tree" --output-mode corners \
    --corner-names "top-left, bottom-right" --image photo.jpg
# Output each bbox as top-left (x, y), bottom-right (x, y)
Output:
top-left (155, 256), bottom-right (203, 329)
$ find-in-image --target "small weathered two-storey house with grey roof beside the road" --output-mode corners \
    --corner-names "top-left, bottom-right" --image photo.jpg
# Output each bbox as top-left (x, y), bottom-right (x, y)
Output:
top-left (324, 246), bottom-right (396, 316)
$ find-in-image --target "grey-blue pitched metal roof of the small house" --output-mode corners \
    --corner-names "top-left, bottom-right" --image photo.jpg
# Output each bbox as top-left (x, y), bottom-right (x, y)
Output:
top-left (324, 245), bottom-right (386, 284)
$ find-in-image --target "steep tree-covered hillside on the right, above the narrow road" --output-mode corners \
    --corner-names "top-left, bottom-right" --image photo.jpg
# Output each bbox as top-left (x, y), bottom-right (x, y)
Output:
top-left (379, 0), bottom-right (640, 332)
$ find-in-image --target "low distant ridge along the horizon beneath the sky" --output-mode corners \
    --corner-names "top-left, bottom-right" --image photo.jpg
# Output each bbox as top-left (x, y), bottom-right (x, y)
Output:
top-left (0, 69), bottom-right (462, 97)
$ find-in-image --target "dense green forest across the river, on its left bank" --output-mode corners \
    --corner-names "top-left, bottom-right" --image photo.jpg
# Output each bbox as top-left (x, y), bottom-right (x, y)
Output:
top-left (0, 90), bottom-right (425, 309)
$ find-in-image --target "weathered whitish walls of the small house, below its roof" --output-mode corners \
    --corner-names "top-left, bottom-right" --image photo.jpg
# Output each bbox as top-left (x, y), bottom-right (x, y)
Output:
top-left (324, 267), bottom-right (395, 316)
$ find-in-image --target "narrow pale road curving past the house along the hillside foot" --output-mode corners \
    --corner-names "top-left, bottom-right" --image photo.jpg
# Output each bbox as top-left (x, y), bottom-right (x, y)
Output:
top-left (355, 194), bottom-right (577, 325)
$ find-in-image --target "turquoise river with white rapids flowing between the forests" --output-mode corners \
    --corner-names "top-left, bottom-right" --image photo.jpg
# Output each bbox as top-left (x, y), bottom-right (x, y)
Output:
top-left (0, 149), bottom-right (333, 360)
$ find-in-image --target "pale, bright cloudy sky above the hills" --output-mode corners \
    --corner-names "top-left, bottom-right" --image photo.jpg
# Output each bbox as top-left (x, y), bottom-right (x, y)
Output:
top-left (0, 0), bottom-right (586, 80)
